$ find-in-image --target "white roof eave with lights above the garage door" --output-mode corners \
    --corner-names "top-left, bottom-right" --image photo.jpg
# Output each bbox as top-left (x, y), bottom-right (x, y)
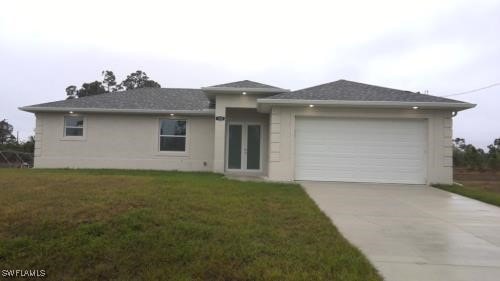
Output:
top-left (257, 99), bottom-right (476, 112)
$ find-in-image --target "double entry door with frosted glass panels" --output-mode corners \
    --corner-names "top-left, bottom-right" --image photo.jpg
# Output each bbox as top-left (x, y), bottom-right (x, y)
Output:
top-left (226, 122), bottom-right (262, 171)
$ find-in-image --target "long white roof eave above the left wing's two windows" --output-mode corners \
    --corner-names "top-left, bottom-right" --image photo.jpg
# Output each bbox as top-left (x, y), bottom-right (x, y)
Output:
top-left (19, 106), bottom-right (215, 116)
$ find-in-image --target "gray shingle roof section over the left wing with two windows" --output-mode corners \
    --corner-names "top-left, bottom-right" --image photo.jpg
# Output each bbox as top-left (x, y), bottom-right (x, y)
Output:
top-left (23, 88), bottom-right (209, 110)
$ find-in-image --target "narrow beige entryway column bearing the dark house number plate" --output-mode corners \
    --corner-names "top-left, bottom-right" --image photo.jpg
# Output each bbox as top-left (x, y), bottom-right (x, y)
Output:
top-left (213, 103), bottom-right (226, 173)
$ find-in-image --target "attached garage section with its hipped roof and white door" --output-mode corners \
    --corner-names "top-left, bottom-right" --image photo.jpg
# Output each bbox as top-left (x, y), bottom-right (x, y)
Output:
top-left (257, 80), bottom-right (474, 184)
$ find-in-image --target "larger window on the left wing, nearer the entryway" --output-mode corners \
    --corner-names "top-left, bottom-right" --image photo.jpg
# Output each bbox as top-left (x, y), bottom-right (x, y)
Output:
top-left (160, 119), bottom-right (187, 151)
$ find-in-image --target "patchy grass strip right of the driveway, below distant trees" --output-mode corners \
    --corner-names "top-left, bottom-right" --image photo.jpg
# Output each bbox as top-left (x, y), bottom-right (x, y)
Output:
top-left (436, 169), bottom-right (500, 207)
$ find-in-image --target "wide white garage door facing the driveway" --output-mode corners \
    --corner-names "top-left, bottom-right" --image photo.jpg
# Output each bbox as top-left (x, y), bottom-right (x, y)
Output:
top-left (295, 117), bottom-right (427, 184)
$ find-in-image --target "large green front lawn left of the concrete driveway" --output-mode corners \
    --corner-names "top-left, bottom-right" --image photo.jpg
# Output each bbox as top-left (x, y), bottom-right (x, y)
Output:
top-left (0, 169), bottom-right (381, 280)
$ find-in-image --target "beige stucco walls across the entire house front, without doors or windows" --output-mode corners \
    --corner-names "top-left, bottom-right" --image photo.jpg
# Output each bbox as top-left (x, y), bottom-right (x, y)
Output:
top-left (30, 100), bottom-right (453, 183)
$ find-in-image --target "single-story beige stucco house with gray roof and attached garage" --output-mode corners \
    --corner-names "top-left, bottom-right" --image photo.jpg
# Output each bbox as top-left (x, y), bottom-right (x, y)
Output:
top-left (20, 80), bottom-right (475, 184)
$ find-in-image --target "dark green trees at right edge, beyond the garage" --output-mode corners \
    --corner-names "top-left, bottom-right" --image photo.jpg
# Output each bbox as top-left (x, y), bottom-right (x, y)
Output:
top-left (453, 138), bottom-right (500, 171)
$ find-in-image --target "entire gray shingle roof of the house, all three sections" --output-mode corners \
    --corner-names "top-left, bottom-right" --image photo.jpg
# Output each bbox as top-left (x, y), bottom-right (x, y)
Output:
top-left (21, 80), bottom-right (473, 114)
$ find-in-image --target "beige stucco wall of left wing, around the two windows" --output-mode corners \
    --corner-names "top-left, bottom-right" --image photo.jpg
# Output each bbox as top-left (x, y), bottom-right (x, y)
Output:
top-left (35, 113), bottom-right (214, 171)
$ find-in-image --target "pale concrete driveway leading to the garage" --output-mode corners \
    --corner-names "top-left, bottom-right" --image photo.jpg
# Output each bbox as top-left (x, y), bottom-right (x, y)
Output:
top-left (301, 182), bottom-right (500, 281)
